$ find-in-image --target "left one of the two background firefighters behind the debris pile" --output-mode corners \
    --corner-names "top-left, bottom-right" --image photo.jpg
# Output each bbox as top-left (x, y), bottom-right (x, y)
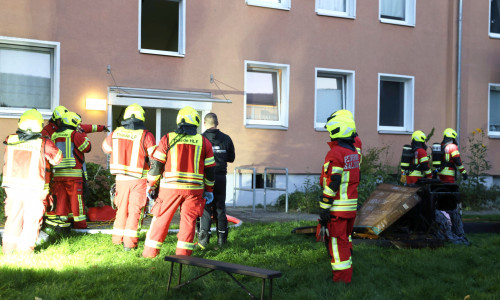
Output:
top-left (406, 130), bottom-right (432, 186)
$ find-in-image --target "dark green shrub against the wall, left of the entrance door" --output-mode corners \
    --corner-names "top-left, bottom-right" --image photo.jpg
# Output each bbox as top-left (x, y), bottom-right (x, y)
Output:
top-left (85, 162), bottom-right (115, 207)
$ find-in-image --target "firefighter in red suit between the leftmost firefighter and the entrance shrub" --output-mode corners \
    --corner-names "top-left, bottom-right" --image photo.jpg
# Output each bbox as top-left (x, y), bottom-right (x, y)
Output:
top-left (46, 112), bottom-right (91, 229)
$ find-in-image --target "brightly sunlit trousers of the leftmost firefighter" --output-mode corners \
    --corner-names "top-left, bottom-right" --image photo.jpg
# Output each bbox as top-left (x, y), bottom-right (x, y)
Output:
top-left (2, 188), bottom-right (47, 253)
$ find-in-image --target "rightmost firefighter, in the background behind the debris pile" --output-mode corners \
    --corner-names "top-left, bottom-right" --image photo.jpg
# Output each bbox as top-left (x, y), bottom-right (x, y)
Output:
top-left (438, 128), bottom-right (468, 183)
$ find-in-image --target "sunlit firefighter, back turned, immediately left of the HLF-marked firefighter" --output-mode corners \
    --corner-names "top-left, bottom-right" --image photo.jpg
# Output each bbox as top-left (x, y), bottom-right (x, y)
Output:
top-left (102, 103), bottom-right (156, 251)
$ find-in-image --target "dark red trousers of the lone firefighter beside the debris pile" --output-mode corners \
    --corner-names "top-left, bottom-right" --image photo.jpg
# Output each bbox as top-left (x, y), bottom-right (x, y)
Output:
top-left (328, 216), bottom-right (355, 283)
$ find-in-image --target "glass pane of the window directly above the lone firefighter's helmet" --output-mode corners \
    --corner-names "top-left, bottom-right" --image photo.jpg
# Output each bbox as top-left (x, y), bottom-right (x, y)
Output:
top-left (316, 73), bottom-right (344, 122)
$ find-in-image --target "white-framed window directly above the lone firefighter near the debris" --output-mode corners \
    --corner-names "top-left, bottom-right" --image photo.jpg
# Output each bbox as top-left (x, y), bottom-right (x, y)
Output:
top-left (314, 68), bottom-right (354, 131)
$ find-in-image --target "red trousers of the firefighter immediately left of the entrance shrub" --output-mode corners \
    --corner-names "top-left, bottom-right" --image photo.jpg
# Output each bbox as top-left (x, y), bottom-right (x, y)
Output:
top-left (53, 180), bottom-right (87, 229)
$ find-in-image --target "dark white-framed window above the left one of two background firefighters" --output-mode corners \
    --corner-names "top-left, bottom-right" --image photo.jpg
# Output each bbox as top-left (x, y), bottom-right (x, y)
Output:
top-left (378, 74), bottom-right (414, 133)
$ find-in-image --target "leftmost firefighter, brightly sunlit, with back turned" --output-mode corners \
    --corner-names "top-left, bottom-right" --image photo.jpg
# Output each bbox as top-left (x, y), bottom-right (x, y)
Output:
top-left (2, 109), bottom-right (62, 253)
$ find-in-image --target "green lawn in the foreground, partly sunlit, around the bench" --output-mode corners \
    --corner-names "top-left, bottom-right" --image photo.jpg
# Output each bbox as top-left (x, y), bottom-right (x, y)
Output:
top-left (0, 222), bottom-right (500, 300)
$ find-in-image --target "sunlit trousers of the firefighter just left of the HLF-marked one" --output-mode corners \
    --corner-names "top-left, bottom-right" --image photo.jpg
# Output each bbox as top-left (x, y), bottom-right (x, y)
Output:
top-left (112, 178), bottom-right (147, 248)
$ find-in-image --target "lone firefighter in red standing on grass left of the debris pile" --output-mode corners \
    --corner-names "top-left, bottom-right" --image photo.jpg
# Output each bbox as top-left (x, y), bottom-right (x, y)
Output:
top-left (319, 116), bottom-right (361, 283)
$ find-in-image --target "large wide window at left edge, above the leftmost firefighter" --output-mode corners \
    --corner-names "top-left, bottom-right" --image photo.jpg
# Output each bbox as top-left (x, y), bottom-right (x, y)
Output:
top-left (0, 36), bottom-right (59, 118)
